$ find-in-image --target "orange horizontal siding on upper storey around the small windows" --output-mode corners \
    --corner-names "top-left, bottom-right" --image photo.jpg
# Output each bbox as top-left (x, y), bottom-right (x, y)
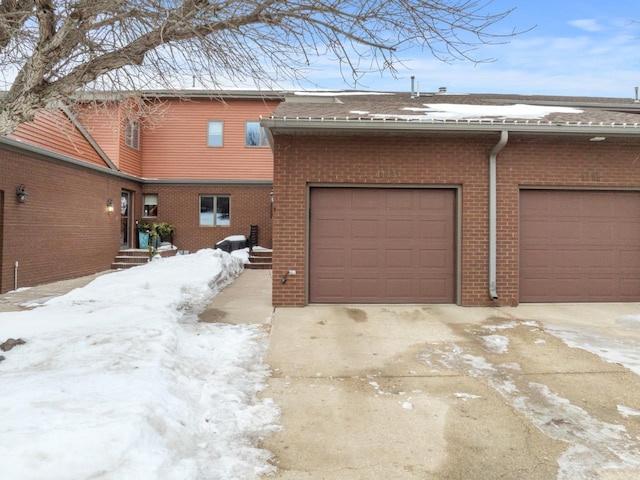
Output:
top-left (141, 99), bottom-right (278, 180)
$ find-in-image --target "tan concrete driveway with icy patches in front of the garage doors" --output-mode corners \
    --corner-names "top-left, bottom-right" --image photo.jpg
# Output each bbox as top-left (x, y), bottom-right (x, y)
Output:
top-left (262, 304), bottom-right (640, 480)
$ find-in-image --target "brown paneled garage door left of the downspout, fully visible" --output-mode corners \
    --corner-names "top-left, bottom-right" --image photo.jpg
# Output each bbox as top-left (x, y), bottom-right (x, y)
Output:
top-left (309, 188), bottom-right (455, 303)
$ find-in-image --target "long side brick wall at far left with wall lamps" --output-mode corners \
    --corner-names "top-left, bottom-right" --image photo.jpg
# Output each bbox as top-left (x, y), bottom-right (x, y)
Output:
top-left (0, 144), bottom-right (139, 292)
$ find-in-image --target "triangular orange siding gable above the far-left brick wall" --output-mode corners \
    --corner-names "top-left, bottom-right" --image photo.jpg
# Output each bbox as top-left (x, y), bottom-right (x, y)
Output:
top-left (9, 110), bottom-right (105, 166)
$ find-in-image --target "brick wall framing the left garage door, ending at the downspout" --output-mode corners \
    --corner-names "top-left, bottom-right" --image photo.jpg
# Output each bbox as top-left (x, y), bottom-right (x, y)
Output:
top-left (273, 136), bottom-right (490, 306)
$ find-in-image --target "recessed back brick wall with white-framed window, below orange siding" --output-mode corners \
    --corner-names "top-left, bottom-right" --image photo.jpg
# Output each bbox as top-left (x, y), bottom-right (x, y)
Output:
top-left (140, 184), bottom-right (272, 253)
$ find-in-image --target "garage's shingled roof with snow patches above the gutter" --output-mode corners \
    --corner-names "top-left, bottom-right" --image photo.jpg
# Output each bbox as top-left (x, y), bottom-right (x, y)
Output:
top-left (263, 91), bottom-right (640, 131)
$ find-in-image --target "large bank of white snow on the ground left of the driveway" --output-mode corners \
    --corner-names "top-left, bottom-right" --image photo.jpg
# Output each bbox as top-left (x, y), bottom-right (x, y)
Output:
top-left (0, 250), bottom-right (279, 480)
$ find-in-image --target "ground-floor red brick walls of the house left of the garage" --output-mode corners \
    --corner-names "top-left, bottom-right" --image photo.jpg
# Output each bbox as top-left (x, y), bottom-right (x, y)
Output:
top-left (0, 142), bottom-right (272, 293)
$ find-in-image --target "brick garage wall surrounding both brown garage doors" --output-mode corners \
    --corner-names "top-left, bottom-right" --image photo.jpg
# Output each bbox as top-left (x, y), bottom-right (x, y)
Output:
top-left (273, 133), bottom-right (640, 306)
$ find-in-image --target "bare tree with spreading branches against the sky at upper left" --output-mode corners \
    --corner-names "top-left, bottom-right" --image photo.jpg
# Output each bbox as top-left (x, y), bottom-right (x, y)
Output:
top-left (0, 0), bottom-right (515, 134)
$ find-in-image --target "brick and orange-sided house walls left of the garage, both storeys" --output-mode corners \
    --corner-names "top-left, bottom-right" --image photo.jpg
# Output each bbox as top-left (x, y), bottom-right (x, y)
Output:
top-left (0, 92), bottom-right (280, 293)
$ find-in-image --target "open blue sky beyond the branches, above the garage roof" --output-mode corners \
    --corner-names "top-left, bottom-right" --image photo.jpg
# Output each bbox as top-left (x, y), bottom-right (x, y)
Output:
top-left (309, 0), bottom-right (640, 98)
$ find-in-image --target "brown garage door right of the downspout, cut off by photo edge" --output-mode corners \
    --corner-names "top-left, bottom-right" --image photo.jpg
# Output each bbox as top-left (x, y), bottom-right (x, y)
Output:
top-left (520, 190), bottom-right (640, 302)
